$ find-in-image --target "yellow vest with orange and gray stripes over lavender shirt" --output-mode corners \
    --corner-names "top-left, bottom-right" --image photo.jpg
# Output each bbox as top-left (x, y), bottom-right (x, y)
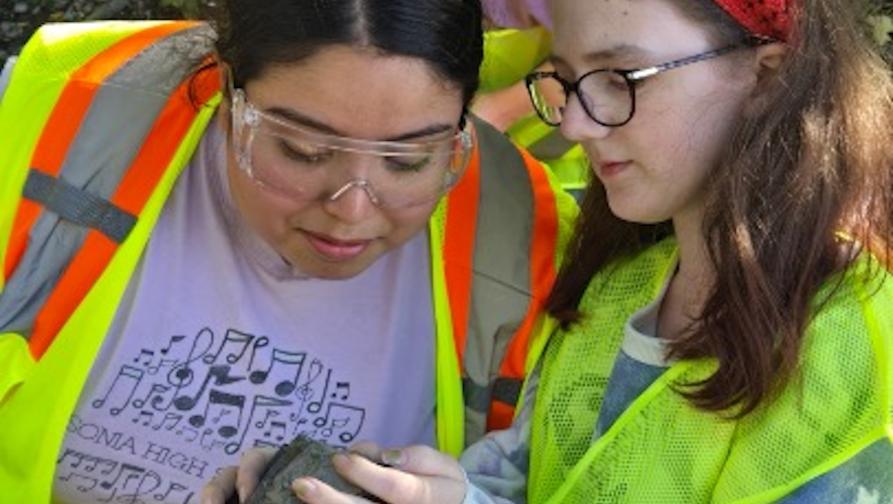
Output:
top-left (0, 22), bottom-right (576, 504)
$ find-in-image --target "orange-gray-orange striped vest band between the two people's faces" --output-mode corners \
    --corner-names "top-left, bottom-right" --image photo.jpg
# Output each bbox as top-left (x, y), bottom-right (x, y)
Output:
top-left (443, 114), bottom-right (569, 443)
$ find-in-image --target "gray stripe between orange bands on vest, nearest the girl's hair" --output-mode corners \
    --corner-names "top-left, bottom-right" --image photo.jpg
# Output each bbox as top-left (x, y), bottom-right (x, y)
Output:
top-left (463, 118), bottom-right (534, 443)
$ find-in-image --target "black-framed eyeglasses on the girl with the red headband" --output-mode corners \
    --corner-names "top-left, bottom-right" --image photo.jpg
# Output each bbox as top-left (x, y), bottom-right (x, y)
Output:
top-left (525, 41), bottom-right (752, 127)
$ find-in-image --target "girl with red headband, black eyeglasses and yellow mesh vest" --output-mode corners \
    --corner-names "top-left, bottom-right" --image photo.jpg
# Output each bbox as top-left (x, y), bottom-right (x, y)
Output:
top-left (214, 0), bottom-right (893, 504)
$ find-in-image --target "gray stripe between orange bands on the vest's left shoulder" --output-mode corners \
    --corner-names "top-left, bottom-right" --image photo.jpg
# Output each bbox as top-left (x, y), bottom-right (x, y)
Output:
top-left (0, 26), bottom-right (211, 338)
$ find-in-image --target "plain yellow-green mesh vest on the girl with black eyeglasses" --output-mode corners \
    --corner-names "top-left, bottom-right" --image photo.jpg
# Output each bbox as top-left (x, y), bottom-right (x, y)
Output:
top-left (528, 243), bottom-right (893, 504)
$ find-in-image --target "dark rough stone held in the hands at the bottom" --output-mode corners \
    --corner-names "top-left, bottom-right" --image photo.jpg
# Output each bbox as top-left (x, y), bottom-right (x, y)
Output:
top-left (239, 436), bottom-right (369, 504)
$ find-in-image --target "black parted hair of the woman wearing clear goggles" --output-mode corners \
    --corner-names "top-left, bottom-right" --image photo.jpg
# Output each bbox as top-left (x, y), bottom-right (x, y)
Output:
top-left (214, 0), bottom-right (483, 105)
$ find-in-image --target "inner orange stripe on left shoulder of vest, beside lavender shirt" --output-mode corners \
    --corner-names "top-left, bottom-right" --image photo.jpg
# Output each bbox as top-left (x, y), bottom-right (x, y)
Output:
top-left (28, 34), bottom-right (220, 359)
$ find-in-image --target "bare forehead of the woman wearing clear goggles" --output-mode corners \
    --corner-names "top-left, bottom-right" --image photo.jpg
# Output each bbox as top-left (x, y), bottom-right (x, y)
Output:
top-left (245, 48), bottom-right (462, 140)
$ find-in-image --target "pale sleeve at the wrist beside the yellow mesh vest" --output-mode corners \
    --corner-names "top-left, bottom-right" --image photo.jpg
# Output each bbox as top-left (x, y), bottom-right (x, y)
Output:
top-left (459, 367), bottom-right (539, 504)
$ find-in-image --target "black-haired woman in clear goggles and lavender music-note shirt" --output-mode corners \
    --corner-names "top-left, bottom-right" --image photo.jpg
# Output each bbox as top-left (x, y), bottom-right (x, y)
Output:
top-left (0, 0), bottom-right (576, 504)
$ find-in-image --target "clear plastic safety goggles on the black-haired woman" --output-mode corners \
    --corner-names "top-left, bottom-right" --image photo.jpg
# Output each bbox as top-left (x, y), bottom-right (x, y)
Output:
top-left (231, 89), bottom-right (474, 208)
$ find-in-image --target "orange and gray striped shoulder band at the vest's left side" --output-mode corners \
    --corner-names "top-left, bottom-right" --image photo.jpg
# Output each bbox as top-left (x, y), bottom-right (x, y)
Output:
top-left (0, 22), bottom-right (220, 358)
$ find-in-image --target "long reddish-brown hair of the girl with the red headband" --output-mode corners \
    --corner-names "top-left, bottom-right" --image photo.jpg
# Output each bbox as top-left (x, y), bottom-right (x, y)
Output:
top-left (547, 0), bottom-right (893, 416)
